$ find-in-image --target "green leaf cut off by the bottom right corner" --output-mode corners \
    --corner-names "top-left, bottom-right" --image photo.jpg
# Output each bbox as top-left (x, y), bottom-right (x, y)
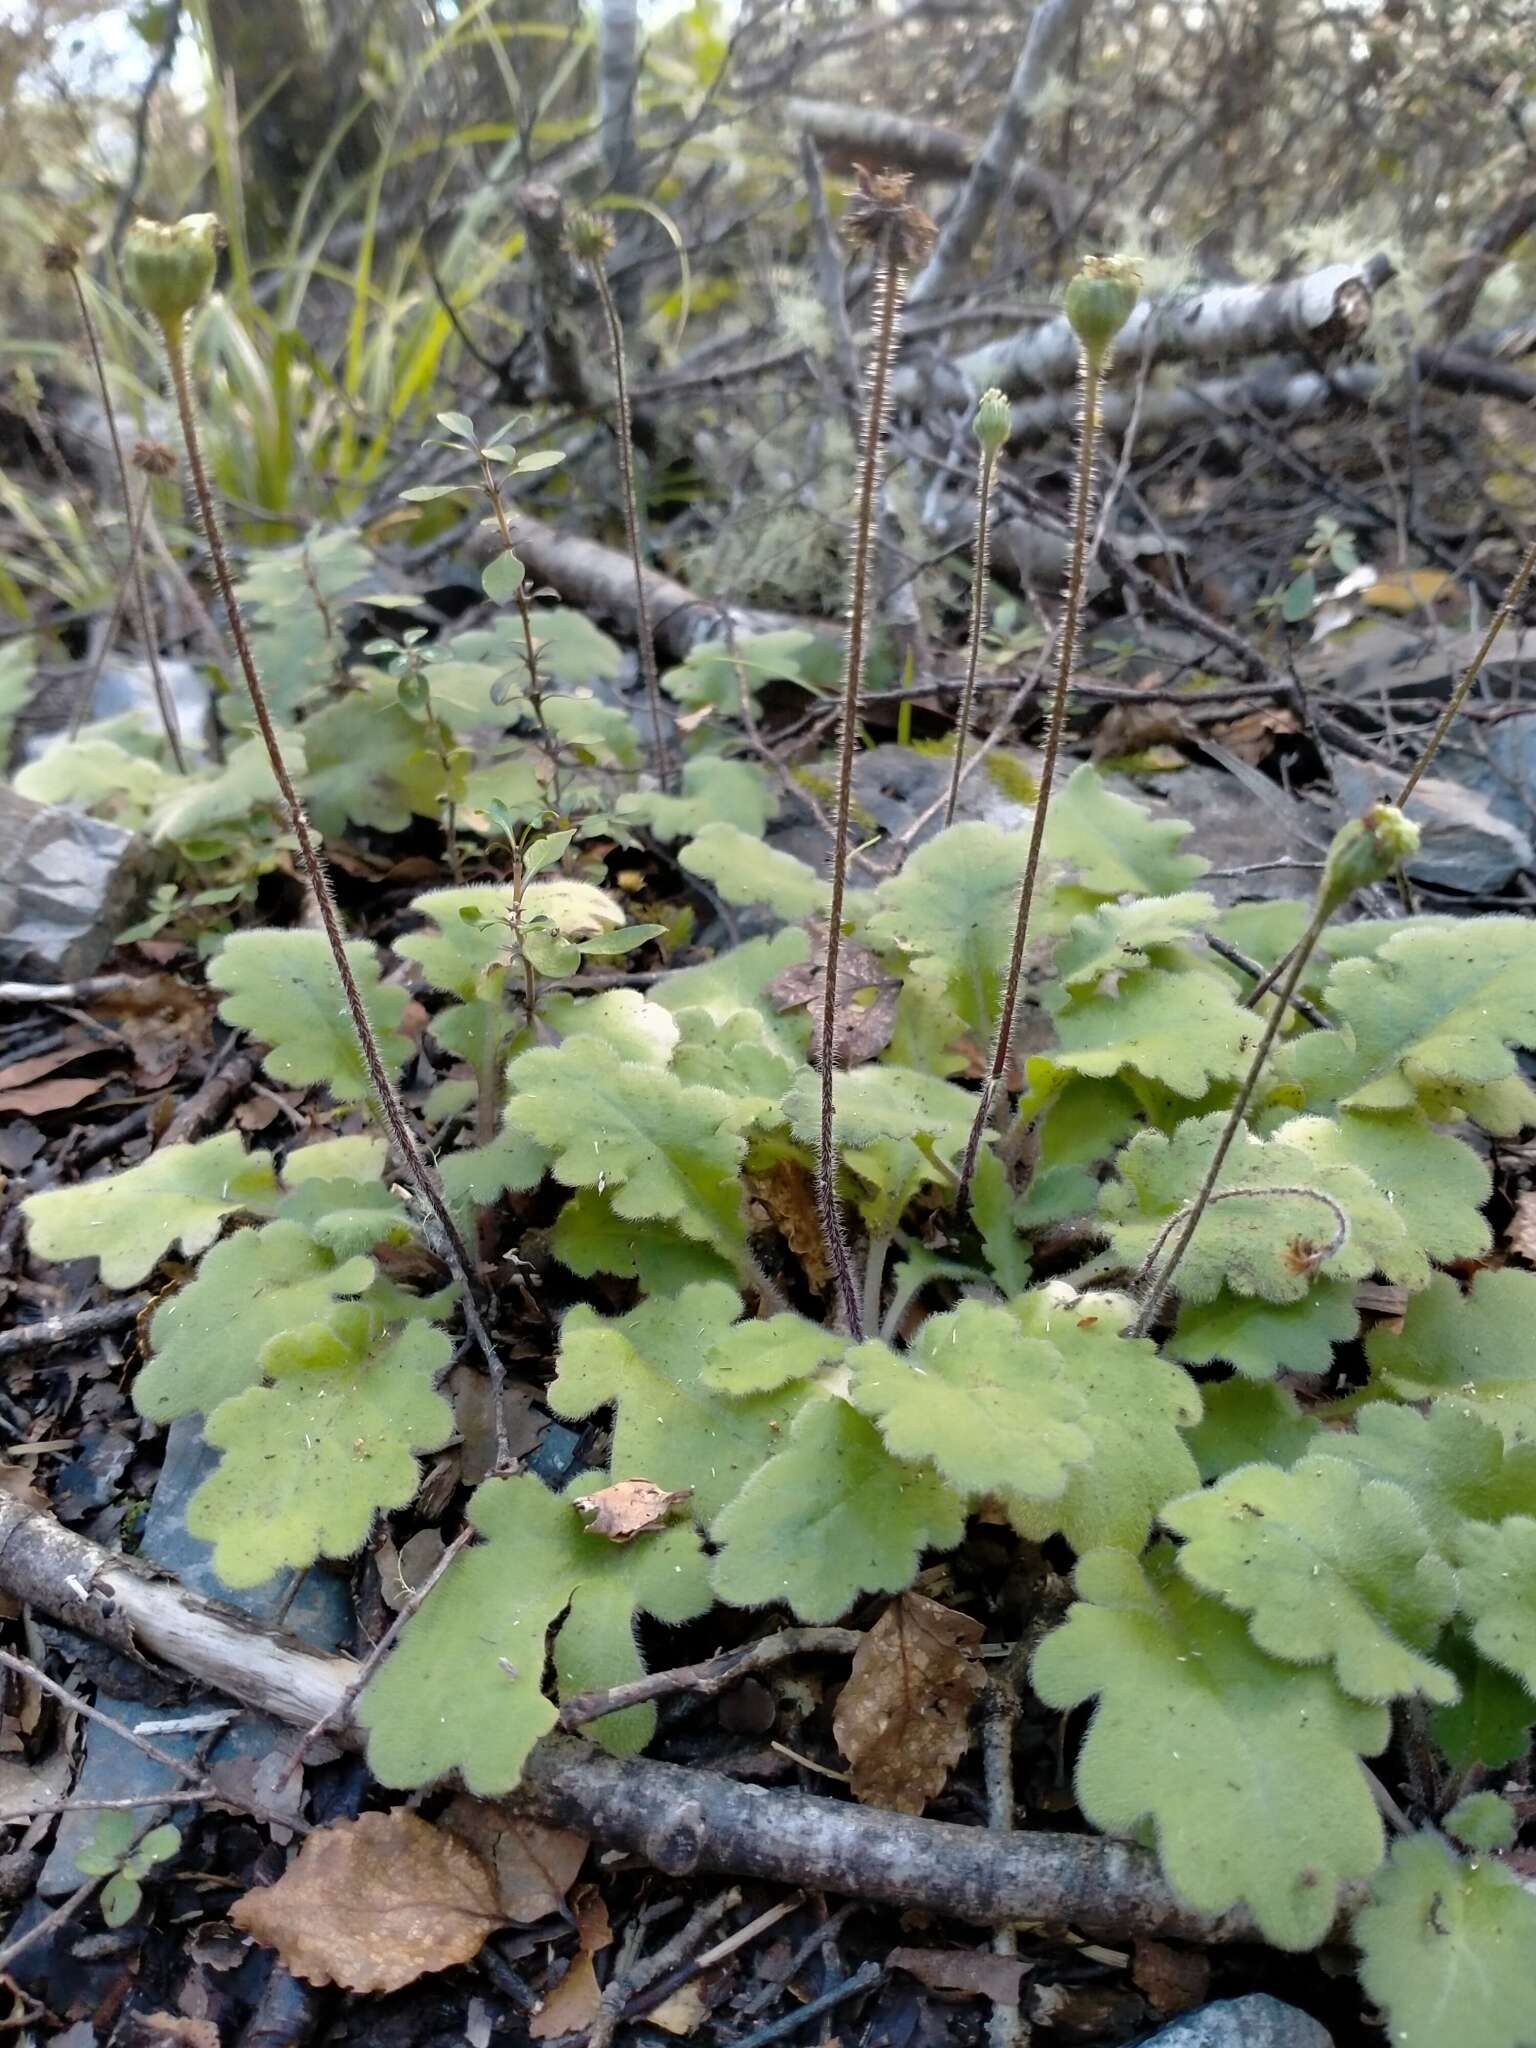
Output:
top-left (1354, 1835), bottom-right (1536, 2048)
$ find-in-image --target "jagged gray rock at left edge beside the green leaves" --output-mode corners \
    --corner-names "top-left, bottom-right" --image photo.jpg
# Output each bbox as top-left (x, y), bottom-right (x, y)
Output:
top-left (0, 786), bottom-right (154, 981)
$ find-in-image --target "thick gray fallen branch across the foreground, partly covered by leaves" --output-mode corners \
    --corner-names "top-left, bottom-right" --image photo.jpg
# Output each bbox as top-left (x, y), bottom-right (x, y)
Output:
top-left (0, 1495), bottom-right (1302, 1942)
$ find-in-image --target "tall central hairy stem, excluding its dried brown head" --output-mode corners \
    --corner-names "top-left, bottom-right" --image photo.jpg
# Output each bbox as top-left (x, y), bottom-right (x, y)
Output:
top-left (815, 251), bottom-right (905, 1337)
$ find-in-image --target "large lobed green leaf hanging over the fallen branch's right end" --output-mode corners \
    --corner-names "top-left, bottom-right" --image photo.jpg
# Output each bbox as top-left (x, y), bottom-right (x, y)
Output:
top-left (1032, 1550), bottom-right (1389, 1948)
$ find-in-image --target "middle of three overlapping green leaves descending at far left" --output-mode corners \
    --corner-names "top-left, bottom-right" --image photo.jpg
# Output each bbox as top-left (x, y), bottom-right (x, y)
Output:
top-left (133, 1223), bottom-right (375, 1421)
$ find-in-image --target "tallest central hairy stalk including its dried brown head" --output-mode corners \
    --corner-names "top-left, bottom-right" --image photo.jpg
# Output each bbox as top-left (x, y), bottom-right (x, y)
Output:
top-left (815, 168), bottom-right (934, 1337)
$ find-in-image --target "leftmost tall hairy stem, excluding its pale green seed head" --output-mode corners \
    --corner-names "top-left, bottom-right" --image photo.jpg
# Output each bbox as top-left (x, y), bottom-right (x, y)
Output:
top-left (162, 322), bottom-right (508, 1464)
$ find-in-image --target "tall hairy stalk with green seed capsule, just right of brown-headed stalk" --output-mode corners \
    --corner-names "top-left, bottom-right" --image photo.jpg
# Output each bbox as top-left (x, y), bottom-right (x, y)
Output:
top-left (956, 256), bottom-right (1141, 1208)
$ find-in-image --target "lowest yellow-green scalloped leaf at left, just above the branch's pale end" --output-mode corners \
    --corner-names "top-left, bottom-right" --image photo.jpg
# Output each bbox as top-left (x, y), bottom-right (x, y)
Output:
top-left (186, 1310), bottom-right (455, 1585)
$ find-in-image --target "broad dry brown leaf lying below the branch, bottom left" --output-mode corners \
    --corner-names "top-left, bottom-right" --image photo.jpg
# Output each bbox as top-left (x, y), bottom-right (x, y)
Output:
top-left (229, 1806), bottom-right (502, 1991)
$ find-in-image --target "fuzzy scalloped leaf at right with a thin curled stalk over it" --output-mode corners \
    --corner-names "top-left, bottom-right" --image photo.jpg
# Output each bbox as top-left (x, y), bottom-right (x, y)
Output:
top-left (1100, 1112), bottom-right (1430, 1300)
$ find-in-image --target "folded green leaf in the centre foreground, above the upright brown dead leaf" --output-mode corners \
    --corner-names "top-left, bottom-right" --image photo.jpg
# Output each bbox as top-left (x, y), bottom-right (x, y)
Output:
top-left (713, 1393), bottom-right (965, 1622)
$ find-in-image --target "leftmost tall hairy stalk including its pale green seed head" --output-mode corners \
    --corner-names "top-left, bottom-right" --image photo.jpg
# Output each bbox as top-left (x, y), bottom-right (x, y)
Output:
top-left (123, 213), bottom-right (510, 1464)
